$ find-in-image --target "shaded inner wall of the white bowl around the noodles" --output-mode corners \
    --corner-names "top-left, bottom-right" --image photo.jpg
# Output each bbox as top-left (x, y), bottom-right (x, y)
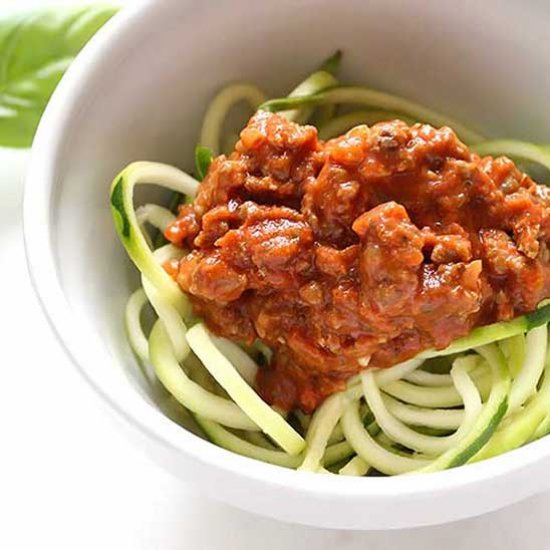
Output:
top-left (28, 0), bottom-right (550, 532)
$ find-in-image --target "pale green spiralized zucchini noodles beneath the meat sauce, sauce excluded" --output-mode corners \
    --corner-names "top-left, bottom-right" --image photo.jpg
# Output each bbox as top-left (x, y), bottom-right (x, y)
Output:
top-left (110, 52), bottom-right (550, 477)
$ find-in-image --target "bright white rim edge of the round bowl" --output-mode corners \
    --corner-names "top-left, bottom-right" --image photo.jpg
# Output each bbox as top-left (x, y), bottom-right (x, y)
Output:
top-left (23, 1), bottom-right (550, 508)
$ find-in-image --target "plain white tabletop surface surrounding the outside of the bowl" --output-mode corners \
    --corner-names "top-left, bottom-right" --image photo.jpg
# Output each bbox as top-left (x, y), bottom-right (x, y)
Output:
top-left (0, 0), bottom-right (550, 550)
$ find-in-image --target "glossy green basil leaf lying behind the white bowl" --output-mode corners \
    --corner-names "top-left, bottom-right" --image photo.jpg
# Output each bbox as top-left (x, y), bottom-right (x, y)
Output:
top-left (0, 5), bottom-right (118, 147)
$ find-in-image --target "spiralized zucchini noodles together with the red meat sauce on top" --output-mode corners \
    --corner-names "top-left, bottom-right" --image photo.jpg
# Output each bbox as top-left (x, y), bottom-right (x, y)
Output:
top-left (111, 53), bottom-right (550, 476)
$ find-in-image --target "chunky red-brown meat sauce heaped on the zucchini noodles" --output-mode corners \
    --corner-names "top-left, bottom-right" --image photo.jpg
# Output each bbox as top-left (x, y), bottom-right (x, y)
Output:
top-left (166, 112), bottom-right (550, 412)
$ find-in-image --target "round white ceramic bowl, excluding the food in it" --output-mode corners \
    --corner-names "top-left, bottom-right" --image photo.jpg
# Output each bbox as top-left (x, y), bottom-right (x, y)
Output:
top-left (25, 0), bottom-right (550, 529)
